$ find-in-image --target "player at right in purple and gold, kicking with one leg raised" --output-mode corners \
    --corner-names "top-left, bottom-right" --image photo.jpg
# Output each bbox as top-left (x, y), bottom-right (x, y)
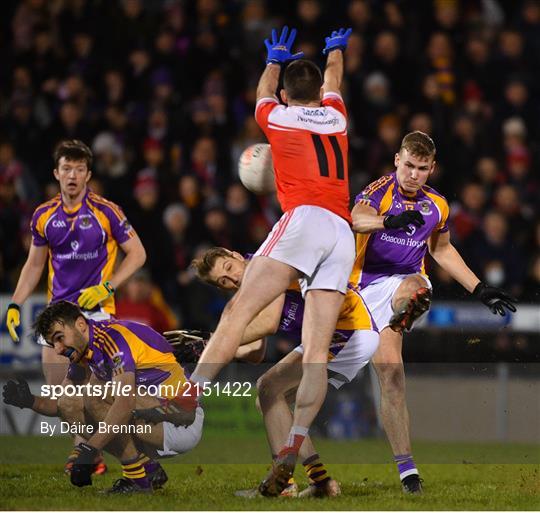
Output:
top-left (352, 132), bottom-right (516, 493)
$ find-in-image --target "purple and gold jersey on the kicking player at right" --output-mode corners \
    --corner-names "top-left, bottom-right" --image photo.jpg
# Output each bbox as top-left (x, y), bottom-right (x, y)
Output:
top-left (351, 172), bottom-right (449, 288)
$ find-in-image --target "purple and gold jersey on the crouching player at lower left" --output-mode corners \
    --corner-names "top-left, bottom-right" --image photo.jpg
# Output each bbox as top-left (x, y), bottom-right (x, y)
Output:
top-left (76, 320), bottom-right (186, 399)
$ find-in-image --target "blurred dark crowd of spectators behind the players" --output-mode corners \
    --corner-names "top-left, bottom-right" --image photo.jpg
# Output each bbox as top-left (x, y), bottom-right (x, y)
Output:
top-left (0, 0), bottom-right (540, 334)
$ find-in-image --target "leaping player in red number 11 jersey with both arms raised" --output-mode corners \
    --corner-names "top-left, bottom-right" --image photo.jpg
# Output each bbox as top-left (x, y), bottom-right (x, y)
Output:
top-left (132, 27), bottom-right (354, 496)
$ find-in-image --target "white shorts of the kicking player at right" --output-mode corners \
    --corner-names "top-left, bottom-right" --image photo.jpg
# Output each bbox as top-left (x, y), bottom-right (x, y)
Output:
top-left (360, 274), bottom-right (433, 332)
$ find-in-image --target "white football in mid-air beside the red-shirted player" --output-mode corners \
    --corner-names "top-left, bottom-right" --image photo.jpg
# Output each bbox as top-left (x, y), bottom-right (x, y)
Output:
top-left (238, 144), bottom-right (276, 194)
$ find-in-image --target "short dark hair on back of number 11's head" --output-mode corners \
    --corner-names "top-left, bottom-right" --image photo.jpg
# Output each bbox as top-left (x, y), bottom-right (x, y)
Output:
top-left (283, 59), bottom-right (323, 102)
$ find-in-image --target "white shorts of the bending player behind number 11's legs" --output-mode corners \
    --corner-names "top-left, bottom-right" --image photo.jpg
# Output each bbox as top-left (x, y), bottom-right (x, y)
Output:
top-left (294, 330), bottom-right (379, 388)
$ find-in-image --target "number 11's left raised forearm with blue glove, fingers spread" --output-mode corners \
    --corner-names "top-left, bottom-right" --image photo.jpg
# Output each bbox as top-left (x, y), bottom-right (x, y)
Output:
top-left (257, 27), bottom-right (304, 101)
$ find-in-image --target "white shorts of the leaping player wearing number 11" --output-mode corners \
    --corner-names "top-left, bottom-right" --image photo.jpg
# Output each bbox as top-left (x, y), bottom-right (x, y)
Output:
top-left (255, 205), bottom-right (355, 294)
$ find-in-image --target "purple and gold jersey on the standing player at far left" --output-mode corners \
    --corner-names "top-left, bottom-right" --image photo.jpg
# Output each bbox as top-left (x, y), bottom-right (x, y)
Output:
top-left (31, 191), bottom-right (135, 314)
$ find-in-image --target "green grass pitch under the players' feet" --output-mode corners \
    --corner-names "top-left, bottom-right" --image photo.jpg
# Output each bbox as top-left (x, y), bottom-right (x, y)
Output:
top-left (0, 435), bottom-right (540, 510)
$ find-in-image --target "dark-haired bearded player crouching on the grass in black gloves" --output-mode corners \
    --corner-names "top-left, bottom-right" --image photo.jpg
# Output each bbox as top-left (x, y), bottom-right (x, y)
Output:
top-left (4, 301), bottom-right (204, 493)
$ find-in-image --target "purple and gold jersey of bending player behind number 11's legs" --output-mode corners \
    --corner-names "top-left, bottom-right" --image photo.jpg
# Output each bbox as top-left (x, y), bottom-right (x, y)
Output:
top-left (278, 284), bottom-right (377, 361)
